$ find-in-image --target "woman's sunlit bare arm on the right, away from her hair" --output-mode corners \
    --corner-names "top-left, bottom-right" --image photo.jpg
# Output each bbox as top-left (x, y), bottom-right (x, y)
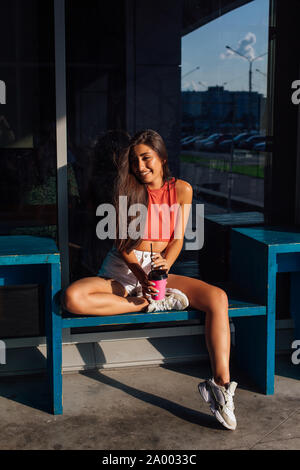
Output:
top-left (153, 180), bottom-right (193, 271)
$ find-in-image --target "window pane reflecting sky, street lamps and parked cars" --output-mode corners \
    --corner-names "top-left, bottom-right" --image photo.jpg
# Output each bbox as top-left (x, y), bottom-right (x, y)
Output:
top-left (180, 0), bottom-right (269, 216)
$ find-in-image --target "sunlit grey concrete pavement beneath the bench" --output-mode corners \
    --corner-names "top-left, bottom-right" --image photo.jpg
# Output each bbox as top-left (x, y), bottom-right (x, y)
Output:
top-left (0, 356), bottom-right (300, 450)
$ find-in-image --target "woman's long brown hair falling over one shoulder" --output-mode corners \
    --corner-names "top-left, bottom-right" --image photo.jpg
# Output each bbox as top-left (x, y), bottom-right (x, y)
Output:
top-left (114, 129), bottom-right (171, 253)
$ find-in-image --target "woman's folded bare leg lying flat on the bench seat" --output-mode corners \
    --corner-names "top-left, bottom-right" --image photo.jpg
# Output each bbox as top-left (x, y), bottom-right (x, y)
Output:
top-left (64, 277), bottom-right (148, 315)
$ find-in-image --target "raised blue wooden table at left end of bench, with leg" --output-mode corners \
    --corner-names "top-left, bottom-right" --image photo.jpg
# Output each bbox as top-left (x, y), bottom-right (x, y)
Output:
top-left (0, 235), bottom-right (62, 412)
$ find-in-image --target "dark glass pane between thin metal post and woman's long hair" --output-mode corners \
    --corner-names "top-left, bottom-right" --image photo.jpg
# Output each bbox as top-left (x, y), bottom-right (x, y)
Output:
top-left (66, 0), bottom-right (128, 281)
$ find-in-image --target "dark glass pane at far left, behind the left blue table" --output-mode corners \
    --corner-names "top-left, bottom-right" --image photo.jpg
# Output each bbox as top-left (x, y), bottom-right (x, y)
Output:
top-left (0, 0), bottom-right (57, 337)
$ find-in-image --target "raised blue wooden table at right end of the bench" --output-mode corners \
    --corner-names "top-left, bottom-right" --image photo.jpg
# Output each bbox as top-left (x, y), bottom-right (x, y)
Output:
top-left (230, 227), bottom-right (300, 394)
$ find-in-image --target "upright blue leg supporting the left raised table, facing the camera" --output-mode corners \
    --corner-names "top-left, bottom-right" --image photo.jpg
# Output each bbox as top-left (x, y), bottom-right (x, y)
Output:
top-left (45, 264), bottom-right (63, 415)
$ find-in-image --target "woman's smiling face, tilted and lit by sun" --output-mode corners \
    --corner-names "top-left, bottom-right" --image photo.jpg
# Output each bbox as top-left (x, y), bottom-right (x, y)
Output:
top-left (131, 144), bottom-right (163, 185)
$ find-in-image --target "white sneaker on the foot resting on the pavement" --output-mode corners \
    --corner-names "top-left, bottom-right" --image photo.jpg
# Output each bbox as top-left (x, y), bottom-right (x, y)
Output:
top-left (198, 379), bottom-right (237, 430)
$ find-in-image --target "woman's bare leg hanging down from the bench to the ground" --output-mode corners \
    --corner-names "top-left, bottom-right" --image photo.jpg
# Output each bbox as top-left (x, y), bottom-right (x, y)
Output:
top-left (167, 274), bottom-right (230, 385)
